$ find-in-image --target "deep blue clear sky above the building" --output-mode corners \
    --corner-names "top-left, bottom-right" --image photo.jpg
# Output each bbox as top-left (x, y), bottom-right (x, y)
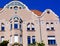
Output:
top-left (0, 0), bottom-right (60, 16)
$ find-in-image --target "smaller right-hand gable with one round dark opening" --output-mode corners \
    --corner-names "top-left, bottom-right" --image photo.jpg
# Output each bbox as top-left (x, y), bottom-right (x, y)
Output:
top-left (41, 9), bottom-right (59, 21)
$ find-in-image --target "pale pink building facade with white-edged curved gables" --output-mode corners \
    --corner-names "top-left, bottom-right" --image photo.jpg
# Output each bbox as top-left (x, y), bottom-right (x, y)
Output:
top-left (0, 1), bottom-right (60, 46)
